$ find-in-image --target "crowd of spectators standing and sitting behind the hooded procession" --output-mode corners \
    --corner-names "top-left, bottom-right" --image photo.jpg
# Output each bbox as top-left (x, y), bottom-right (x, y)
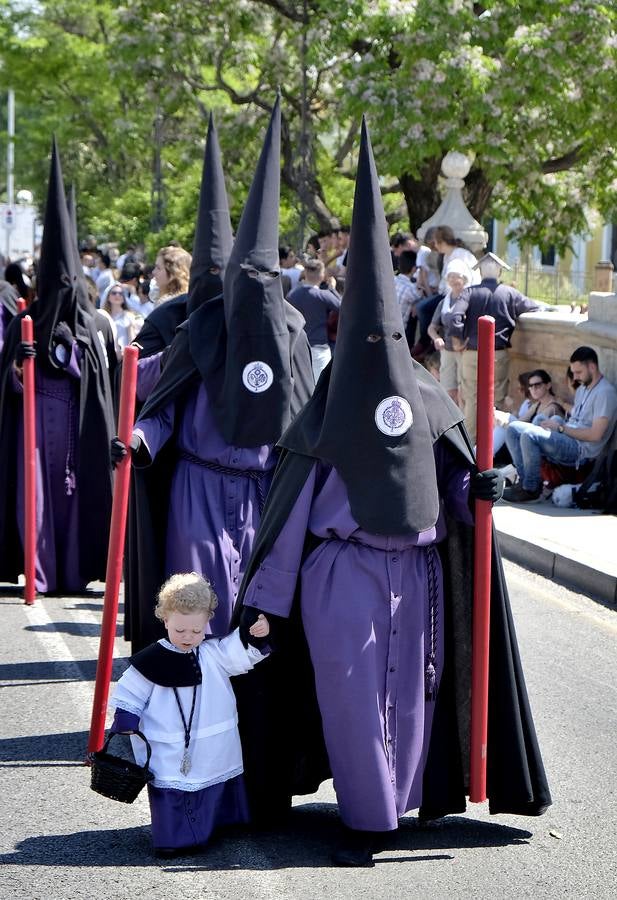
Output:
top-left (4, 224), bottom-right (617, 502)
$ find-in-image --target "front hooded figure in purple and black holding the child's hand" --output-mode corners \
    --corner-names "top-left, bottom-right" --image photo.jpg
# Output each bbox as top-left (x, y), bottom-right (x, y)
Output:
top-left (232, 123), bottom-right (551, 866)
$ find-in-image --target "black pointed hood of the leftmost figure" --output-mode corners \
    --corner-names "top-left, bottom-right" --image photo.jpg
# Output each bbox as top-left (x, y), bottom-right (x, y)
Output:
top-left (31, 138), bottom-right (90, 369)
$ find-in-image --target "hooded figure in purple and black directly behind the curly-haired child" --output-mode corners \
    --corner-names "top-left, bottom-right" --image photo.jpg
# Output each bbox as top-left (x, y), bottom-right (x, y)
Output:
top-left (119, 100), bottom-right (313, 650)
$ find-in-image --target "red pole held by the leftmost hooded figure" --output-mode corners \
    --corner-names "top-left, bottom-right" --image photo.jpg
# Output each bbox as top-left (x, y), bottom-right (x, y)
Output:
top-left (21, 316), bottom-right (36, 606)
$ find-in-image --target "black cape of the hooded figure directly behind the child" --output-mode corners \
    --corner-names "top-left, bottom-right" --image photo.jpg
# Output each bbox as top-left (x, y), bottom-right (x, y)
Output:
top-left (124, 296), bottom-right (312, 651)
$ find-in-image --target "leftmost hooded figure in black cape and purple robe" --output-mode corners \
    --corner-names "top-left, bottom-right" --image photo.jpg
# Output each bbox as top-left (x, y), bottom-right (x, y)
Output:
top-left (0, 142), bottom-right (113, 592)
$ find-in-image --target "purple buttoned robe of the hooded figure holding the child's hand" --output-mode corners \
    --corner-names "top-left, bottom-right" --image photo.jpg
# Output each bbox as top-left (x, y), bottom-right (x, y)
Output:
top-left (244, 445), bottom-right (471, 831)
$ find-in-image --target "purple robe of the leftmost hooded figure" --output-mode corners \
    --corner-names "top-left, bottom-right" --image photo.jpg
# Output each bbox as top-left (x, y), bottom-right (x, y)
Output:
top-left (13, 342), bottom-right (87, 594)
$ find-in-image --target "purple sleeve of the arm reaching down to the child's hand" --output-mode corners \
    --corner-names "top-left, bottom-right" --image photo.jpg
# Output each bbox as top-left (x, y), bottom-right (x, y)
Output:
top-left (244, 466), bottom-right (316, 618)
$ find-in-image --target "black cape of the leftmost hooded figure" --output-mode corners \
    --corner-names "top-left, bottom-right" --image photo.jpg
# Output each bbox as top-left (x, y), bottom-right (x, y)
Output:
top-left (0, 304), bottom-right (114, 582)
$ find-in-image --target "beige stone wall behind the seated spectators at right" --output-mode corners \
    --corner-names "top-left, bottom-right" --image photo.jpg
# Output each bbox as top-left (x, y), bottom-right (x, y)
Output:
top-left (510, 292), bottom-right (617, 398)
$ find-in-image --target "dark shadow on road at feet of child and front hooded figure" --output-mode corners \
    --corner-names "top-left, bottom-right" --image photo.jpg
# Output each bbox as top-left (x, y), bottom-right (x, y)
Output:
top-left (0, 803), bottom-right (531, 873)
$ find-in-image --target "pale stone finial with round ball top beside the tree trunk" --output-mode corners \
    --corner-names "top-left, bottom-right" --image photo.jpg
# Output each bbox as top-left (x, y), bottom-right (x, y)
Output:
top-left (417, 150), bottom-right (488, 254)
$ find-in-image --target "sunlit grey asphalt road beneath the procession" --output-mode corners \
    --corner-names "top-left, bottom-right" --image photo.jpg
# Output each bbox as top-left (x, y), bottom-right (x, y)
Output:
top-left (0, 564), bottom-right (617, 900)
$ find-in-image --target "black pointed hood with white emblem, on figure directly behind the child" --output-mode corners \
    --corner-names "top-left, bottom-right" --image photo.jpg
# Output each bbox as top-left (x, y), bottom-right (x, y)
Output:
top-left (200, 97), bottom-right (298, 447)
